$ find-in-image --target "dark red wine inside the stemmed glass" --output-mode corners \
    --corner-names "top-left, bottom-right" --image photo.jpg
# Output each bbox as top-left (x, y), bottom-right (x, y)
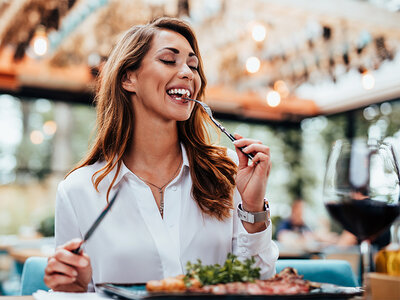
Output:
top-left (326, 199), bottom-right (400, 241)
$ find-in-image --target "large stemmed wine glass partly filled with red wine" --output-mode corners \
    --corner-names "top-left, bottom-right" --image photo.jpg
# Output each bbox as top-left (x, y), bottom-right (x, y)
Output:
top-left (323, 139), bottom-right (400, 280)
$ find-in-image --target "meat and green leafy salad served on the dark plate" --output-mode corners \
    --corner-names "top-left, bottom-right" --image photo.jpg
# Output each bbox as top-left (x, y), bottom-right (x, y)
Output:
top-left (146, 254), bottom-right (319, 295)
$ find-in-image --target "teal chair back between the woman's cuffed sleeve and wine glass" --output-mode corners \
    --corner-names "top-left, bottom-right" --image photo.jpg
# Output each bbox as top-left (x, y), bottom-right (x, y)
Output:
top-left (276, 259), bottom-right (358, 287)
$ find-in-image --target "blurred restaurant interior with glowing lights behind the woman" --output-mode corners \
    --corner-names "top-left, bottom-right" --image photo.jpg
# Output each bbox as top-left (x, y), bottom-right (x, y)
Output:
top-left (0, 0), bottom-right (400, 299)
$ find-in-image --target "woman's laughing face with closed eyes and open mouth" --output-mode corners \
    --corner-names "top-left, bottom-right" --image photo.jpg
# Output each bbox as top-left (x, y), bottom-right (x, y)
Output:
top-left (124, 30), bottom-right (201, 121)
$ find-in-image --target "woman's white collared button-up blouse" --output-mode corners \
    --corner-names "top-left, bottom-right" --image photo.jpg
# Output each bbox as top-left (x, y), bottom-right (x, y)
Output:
top-left (55, 146), bottom-right (278, 290)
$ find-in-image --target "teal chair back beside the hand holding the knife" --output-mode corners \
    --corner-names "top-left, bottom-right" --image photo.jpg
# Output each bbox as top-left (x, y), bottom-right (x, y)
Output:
top-left (21, 256), bottom-right (49, 296)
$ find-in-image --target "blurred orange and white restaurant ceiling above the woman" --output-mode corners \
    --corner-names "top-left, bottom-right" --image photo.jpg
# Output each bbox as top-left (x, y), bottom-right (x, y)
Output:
top-left (0, 0), bottom-right (400, 122)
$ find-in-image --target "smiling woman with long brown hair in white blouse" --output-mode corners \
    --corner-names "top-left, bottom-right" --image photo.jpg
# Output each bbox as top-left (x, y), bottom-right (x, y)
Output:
top-left (44, 18), bottom-right (278, 292)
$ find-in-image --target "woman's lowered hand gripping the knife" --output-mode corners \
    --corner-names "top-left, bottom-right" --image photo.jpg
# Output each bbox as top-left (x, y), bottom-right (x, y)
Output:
top-left (44, 239), bottom-right (92, 292)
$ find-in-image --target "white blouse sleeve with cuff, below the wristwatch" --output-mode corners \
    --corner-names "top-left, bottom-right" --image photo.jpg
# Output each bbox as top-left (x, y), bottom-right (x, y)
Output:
top-left (232, 190), bottom-right (279, 279)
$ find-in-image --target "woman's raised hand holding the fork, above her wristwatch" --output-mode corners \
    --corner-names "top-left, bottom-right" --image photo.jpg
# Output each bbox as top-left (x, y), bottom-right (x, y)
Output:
top-left (233, 134), bottom-right (271, 212)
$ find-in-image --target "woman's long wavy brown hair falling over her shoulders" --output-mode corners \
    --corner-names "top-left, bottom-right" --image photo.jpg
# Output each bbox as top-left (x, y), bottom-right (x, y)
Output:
top-left (67, 17), bottom-right (237, 220)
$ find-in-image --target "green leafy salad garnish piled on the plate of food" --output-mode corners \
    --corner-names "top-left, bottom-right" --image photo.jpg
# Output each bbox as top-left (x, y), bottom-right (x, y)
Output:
top-left (184, 253), bottom-right (260, 287)
